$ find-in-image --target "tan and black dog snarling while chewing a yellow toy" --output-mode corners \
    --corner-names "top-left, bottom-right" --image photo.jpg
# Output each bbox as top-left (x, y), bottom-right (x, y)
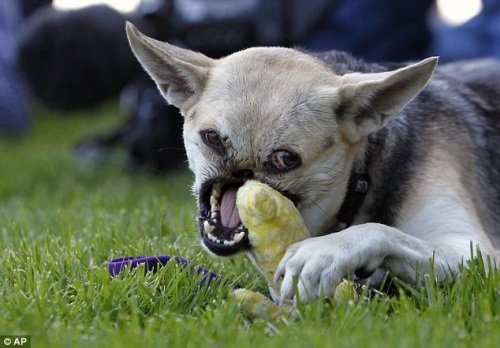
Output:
top-left (127, 23), bottom-right (500, 303)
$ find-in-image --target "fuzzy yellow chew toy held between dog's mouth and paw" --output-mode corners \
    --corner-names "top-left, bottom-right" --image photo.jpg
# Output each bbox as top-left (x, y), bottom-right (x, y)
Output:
top-left (233, 180), bottom-right (355, 318)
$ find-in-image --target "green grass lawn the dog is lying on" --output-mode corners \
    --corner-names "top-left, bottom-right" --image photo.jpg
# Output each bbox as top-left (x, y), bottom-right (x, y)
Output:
top-left (0, 104), bottom-right (500, 347)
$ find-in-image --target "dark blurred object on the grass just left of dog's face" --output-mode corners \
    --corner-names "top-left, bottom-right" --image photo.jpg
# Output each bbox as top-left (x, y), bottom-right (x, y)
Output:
top-left (75, 82), bottom-right (186, 174)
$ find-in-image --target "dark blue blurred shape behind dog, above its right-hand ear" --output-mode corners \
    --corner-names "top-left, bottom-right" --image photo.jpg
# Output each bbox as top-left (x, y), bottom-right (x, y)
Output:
top-left (305, 0), bottom-right (434, 62)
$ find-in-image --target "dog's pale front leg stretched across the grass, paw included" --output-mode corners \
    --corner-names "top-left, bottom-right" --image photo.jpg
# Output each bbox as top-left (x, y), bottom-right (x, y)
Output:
top-left (274, 223), bottom-right (476, 304)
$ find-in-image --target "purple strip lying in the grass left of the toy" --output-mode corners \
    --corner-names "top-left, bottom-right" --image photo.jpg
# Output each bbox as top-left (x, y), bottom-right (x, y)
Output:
top-left (108, 255), bottom-right (220, 286)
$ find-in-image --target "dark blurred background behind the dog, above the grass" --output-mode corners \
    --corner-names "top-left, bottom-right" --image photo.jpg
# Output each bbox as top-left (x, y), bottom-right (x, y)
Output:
top-left (0, 0), bottom-right (500, 173)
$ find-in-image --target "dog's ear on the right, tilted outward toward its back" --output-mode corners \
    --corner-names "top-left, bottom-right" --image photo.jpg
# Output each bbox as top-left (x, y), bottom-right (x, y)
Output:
top-left (335, 57), bottom-right (438, 141)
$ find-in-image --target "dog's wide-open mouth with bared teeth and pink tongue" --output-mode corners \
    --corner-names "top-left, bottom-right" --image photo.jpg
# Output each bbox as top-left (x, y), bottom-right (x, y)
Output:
top-left (199, 182), bottom-right (249, 256)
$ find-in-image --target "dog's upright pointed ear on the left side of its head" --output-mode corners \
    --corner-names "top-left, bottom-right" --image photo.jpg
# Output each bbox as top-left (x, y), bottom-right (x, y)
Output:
top-left (127, 22), bottom-right (215, 111)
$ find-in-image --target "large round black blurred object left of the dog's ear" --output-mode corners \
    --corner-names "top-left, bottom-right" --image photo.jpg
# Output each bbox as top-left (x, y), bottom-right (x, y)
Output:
top-left (18, 6), bottom-right (140, 111)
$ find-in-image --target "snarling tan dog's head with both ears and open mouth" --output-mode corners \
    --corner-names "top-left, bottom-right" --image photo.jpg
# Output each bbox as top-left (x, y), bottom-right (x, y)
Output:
top-left (127, 24), bottom-right (436, 255)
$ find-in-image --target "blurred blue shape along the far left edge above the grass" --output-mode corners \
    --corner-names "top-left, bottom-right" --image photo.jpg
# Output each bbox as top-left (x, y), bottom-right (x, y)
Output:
top-left (0, 0), bottom-right (29, 136)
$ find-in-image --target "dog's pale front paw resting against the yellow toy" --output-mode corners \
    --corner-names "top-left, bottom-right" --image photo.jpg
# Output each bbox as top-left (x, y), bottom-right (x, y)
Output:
top-left (274, 228), bottom-right (385, 304)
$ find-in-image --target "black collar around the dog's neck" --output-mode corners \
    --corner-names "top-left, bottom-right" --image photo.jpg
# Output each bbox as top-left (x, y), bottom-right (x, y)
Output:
top-left (337, 159), bottom-right (370, 230)
